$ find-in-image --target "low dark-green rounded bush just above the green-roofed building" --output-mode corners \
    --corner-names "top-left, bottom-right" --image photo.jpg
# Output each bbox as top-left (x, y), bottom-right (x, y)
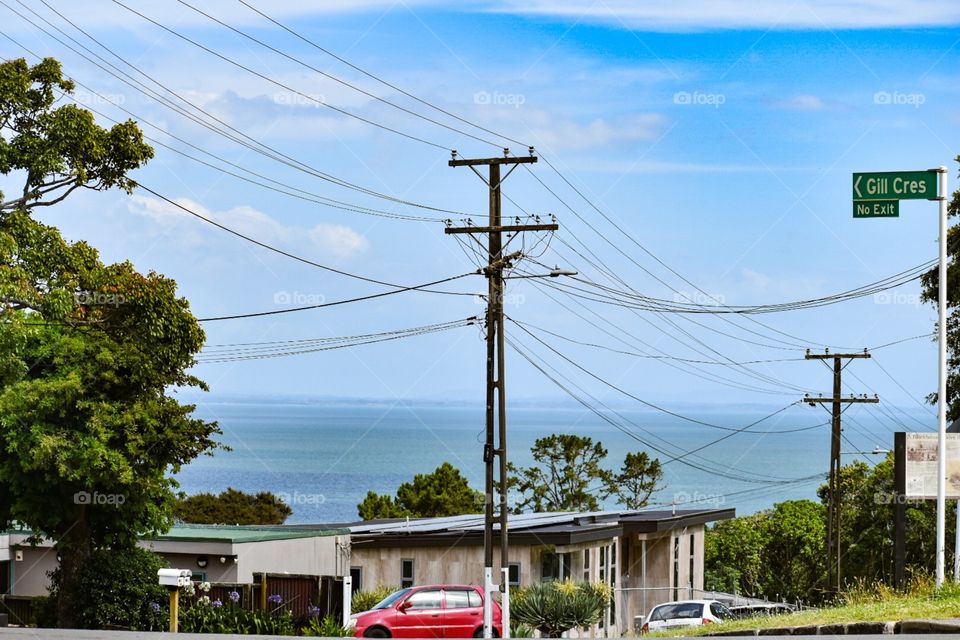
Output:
top-left (173, 488), bottom-right (293, 525)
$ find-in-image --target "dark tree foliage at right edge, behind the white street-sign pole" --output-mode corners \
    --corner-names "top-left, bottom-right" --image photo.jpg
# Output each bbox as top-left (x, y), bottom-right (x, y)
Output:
top-left (920, 156), bottom-right (960, 421)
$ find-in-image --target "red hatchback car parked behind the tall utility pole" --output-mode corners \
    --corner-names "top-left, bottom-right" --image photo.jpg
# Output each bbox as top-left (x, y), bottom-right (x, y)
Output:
top-left (348, 584), bottom-right (503, 638)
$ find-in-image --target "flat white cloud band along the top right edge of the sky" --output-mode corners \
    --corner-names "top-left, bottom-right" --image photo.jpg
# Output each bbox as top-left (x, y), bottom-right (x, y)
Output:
top-left (489, 0), bottom-right (960, 31)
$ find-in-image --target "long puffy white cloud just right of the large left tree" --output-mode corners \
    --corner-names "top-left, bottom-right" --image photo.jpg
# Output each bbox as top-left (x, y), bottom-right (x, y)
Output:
top-left (127, 195), bottom-right (369, 258)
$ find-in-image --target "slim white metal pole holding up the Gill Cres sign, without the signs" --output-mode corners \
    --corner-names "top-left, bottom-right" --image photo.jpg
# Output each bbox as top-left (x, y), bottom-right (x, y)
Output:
top-left (934, 167), bottom-right (947, 588)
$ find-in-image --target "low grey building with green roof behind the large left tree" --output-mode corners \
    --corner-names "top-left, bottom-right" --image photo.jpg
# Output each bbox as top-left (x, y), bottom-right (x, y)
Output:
top-left (0, 525), bottom-right (350, 596)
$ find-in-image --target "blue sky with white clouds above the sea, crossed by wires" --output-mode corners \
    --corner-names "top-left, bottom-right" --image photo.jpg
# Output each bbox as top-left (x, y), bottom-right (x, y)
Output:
top-left (0, 0), bottom-right (960, 428)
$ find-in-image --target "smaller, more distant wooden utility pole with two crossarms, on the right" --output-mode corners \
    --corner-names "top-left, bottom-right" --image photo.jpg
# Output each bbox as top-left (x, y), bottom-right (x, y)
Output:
top-left (803, 349), bottom-right (880, 593)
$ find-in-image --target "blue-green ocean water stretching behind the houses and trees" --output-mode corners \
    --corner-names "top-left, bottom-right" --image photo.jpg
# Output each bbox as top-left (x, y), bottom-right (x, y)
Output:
top-left (177, 402), bottom-right (895, 523)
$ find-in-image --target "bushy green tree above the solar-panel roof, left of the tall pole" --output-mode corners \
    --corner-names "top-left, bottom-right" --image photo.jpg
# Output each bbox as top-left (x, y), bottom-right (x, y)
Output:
top-left (357, 462), bottom-right (483, 520)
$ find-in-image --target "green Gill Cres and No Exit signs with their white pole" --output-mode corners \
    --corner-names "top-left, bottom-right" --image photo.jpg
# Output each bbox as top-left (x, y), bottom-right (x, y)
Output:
top-left (853, 167), bottom-right (948, 588)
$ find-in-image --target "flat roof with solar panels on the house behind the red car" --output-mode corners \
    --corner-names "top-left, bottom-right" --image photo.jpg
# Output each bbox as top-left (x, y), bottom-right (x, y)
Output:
top-left (289, 509), bottom-right (735, 546)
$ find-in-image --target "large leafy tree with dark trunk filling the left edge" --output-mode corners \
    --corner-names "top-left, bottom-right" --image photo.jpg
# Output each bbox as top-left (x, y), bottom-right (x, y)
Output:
top-left (0, 59), bottom-right (219, 626)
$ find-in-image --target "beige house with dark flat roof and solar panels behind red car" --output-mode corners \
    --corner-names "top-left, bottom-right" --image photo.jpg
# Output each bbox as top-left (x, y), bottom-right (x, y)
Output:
top-left (324, 509), bottom-right (735, 634)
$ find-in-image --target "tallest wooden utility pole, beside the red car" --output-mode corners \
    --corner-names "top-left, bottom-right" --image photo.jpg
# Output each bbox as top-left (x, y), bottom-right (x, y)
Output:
top-left (445, 147), bottom-right (559, 638)
